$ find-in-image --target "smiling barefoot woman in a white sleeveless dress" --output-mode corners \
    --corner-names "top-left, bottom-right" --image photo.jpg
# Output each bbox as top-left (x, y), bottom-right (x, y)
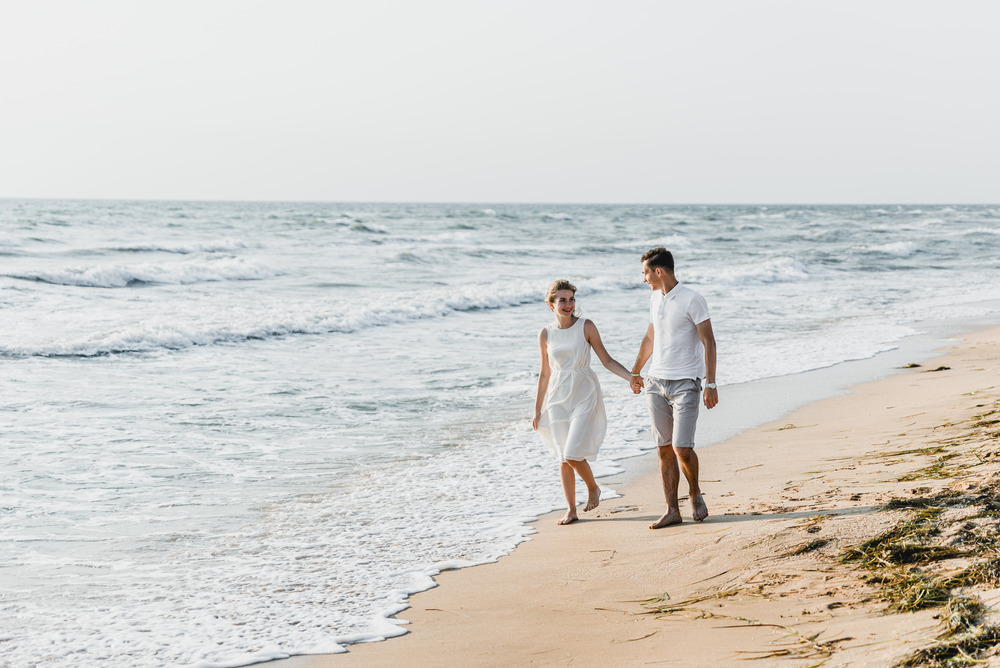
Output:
top-left (531, 280), bottom-right (632, 524)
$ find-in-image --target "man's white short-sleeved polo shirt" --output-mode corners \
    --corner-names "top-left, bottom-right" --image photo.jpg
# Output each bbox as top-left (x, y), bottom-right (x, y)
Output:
top-left (649, 283), bottom-right (708, 380)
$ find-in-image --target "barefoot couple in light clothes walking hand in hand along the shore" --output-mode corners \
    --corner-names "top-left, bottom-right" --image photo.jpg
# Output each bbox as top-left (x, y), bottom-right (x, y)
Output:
top-left (531, 246), bottom-right (719, 529)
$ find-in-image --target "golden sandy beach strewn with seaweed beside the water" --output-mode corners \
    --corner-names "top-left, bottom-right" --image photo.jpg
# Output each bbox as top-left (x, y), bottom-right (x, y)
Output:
top-left (273, 329), bottom-right (1000, 668)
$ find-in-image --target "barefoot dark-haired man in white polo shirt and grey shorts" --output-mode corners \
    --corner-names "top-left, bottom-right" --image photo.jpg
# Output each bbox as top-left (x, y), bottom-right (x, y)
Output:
top-left (632, 246), bottom-right (719, 529)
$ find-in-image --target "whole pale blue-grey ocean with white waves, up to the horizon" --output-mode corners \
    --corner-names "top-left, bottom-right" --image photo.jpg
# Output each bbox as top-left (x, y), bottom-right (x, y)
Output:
top-left (0, 200), bottom-right (1000, 668)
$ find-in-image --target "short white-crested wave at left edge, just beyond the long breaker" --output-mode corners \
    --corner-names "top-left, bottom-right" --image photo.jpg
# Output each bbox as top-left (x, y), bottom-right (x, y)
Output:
top-left (4, 256), bottom-right (278, 288)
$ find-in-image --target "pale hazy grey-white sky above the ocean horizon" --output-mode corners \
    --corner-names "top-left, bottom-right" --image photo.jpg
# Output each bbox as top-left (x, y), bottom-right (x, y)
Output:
top-left (0, 0), bottom-right (1000, 204)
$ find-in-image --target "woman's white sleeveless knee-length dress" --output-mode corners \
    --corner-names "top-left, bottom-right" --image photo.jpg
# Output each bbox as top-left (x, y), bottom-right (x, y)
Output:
top-left (538, 318), bottom-right (608, 462)
